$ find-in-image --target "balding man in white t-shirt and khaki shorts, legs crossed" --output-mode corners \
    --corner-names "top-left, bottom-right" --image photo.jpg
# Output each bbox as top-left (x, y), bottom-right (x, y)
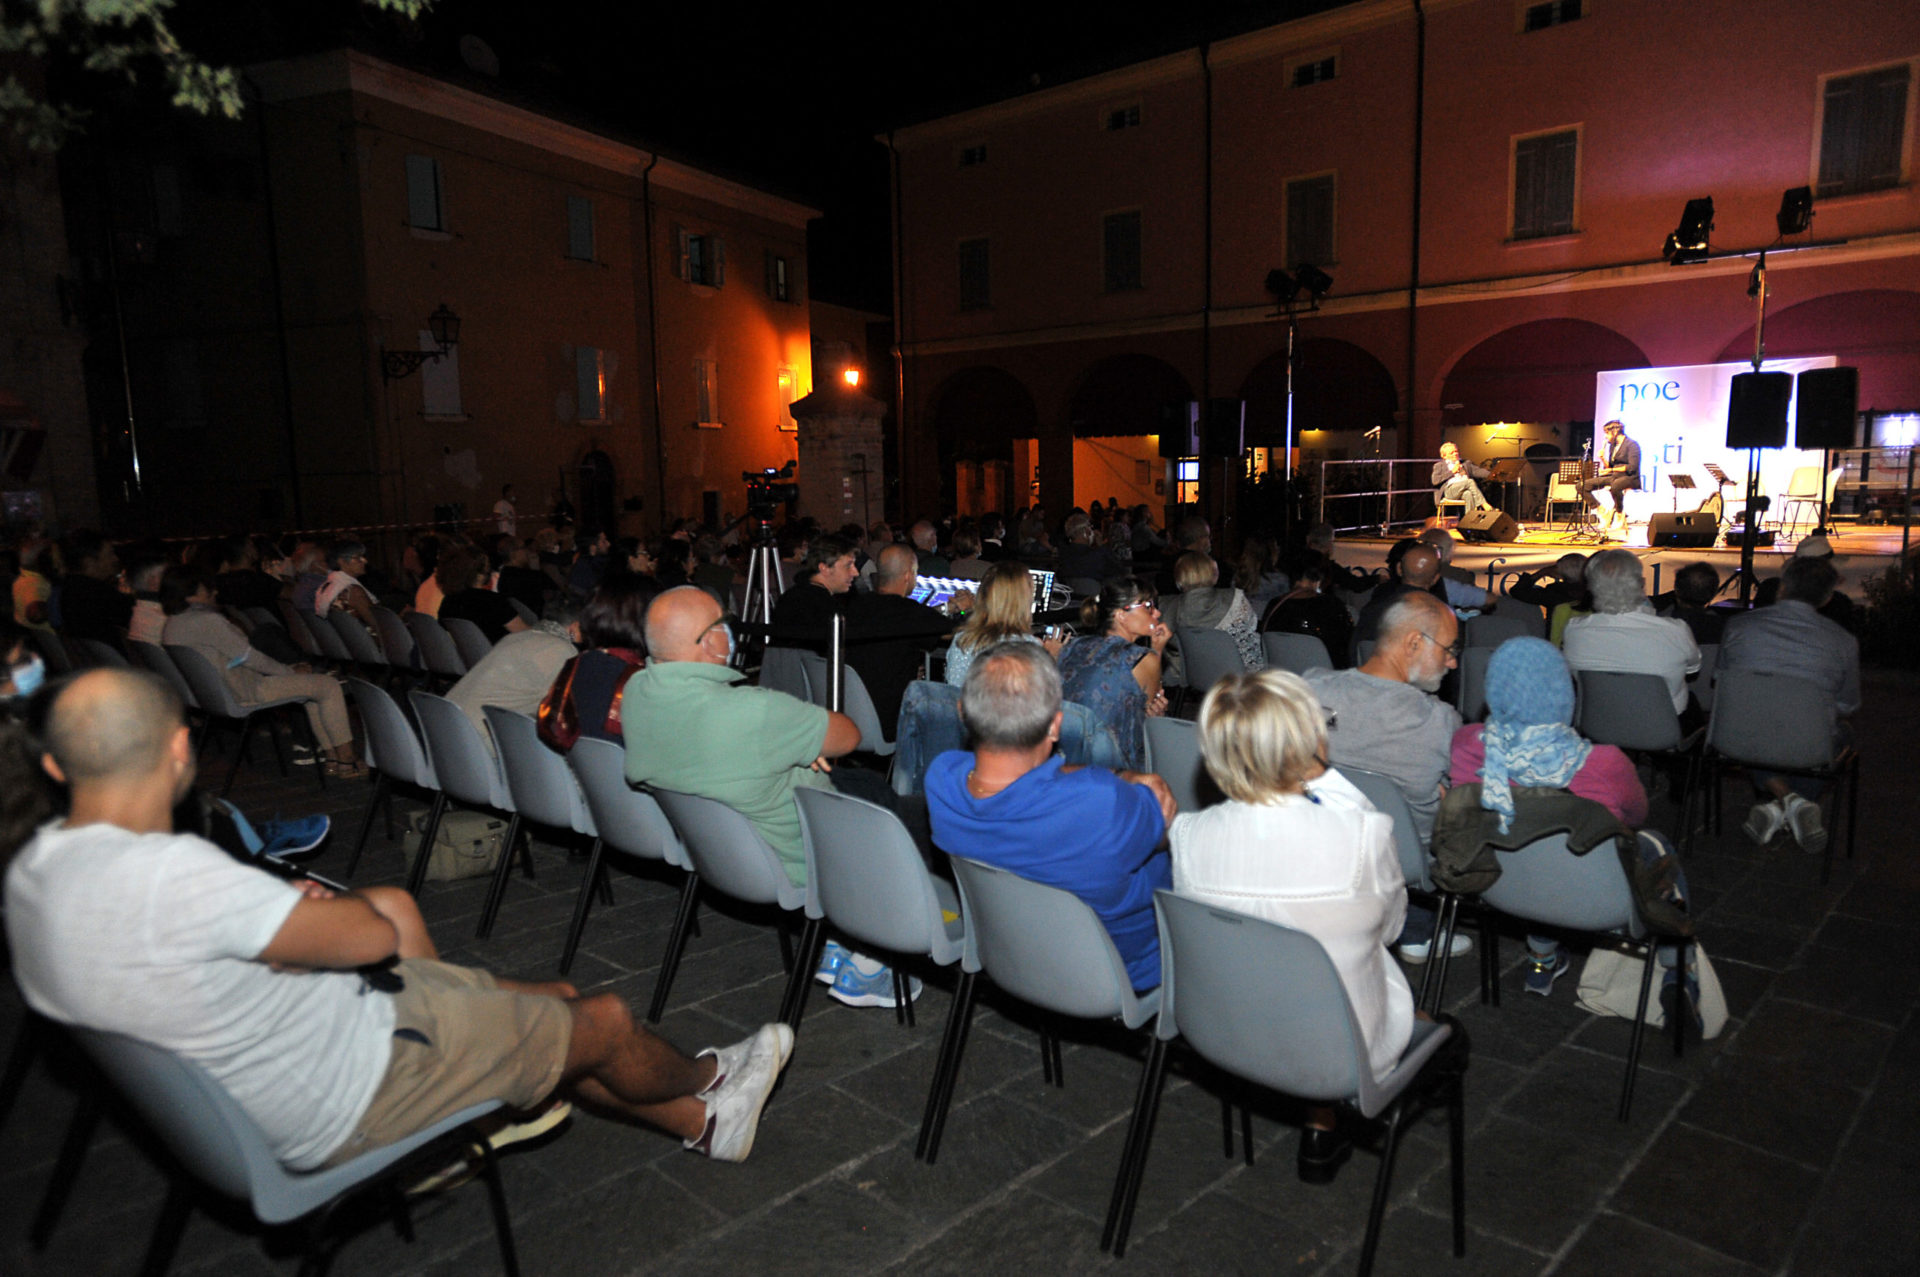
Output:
top-left (6, 670), bottom-right (793, 1169)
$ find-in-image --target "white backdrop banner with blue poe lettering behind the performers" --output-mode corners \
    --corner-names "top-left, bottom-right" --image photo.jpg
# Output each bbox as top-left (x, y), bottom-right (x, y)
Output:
top-left (1594, 355), bottom-right (1837, 509)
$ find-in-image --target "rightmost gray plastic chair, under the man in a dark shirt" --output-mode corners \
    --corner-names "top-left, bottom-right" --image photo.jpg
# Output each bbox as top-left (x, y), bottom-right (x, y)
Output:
top-left (1712, 670), bottom-right (1860, 883)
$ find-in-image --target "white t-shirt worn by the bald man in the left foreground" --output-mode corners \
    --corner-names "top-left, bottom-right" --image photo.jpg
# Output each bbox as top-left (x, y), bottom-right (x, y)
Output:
top-left (6, 822), bottom-right (394, 1169)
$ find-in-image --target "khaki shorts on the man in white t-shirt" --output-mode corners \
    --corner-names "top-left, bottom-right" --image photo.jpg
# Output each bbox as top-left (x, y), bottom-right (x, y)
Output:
top-left (326, 958), bottom-right (574, 1166)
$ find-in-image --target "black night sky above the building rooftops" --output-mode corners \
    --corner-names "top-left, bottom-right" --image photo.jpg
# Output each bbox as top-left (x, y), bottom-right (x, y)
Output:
top-left (177, 0), bottom-right (1340, 313)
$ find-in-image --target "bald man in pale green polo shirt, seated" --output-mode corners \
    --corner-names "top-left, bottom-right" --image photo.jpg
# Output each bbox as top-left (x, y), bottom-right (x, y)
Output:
top-left (620, 586), bottom-right (860, 885)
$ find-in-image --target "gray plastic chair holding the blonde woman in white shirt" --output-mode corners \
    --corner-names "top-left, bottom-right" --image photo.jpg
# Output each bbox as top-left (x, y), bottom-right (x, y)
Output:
top-left (1108, 891), bottom-right (1467, 1277)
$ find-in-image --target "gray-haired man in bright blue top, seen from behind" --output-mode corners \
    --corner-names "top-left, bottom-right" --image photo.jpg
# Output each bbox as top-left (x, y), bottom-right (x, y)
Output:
top-left (925, 643), bottom-right (1173, 989)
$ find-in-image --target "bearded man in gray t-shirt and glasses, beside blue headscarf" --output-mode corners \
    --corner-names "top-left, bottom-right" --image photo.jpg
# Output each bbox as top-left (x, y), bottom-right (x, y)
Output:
top-left (1306, 591), bottom-right (1473, 964)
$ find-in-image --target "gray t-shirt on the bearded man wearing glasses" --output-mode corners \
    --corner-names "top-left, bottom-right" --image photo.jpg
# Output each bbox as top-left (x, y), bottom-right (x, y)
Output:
top-left (1306, 670), bottom-right (1459, 843)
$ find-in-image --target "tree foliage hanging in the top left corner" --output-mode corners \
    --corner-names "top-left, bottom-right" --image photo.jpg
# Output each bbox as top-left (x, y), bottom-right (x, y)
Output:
top-left (0, 0), bottom-right (432, 152)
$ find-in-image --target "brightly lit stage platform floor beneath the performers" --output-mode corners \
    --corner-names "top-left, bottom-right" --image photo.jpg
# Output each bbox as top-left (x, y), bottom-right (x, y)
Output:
top-left (1334, 522), bottom-right (1920, 599)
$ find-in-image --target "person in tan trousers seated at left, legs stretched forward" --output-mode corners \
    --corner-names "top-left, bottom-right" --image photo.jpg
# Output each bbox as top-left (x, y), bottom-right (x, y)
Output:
top-left (159, 566), bottom-right (367, 780)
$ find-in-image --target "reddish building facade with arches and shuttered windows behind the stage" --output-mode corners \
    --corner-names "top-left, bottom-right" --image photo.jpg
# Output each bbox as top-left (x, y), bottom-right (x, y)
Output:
top-left (891, 0), bottom-right (1920, 530)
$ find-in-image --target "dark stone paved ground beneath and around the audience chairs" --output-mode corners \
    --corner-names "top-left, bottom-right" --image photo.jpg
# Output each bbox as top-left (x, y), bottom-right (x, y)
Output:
top-left (0, 676), bottom-right (1920, 1277)
